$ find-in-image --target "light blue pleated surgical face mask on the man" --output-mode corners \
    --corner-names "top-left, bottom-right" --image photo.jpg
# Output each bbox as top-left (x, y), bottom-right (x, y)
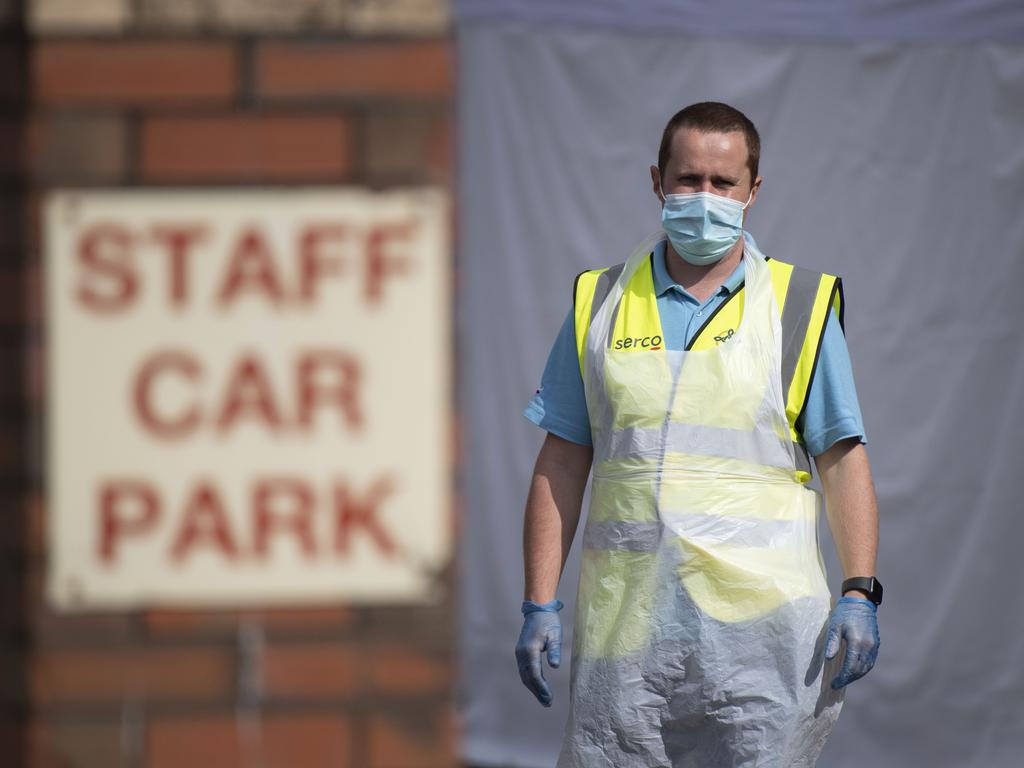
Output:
top-left (662, 189), bottom-right (754, 266)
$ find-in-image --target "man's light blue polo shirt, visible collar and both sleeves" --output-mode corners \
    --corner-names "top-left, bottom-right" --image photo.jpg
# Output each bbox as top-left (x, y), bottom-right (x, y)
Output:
top-left (523, 241), bottom-right (867, 456)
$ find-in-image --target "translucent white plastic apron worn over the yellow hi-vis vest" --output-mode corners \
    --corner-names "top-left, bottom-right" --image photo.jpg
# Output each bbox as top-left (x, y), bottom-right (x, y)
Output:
top-left (558, 234), bottom-right (842, 768)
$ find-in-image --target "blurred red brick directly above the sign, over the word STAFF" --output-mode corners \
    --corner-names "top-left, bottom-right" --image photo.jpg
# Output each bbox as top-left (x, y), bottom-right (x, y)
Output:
top-left (141, 116), bottom-right (351, 181)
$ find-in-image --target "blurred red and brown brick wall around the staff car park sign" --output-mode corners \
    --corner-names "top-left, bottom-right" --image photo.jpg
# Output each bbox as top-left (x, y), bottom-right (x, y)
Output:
top-left (11, 0), bottom-right (457, 768)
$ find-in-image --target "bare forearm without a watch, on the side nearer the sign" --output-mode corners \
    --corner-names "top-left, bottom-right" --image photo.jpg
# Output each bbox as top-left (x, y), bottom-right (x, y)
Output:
top-left (522, 433), bottom-right (593, 603)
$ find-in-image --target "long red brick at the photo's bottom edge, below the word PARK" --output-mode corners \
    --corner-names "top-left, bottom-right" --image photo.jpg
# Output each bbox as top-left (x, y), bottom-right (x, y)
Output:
top-left (146, 714), bottom-right (352, 768)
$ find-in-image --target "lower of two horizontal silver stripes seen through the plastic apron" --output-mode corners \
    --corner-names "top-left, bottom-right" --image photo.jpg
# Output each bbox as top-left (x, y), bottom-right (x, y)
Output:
top-left (583, 518), bottom-right (814, 552)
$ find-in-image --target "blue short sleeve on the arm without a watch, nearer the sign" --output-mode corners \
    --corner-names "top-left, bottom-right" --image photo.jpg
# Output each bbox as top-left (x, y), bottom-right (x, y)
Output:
top-left (522, 309), bottom-right (592, 445)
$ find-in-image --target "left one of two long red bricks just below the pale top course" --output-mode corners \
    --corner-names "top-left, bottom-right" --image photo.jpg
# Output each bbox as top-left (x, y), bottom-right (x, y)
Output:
top-left (32, 41), bottom-right (238, 104)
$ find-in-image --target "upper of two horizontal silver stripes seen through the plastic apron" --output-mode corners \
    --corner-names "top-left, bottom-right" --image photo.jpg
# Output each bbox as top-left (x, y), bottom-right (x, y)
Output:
top-left (606, 422), bottom-right (793, 469)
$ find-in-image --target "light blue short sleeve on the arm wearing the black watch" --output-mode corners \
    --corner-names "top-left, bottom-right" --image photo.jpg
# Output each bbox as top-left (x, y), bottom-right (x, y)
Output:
top-left (796, 312), bottom-right (867, 456)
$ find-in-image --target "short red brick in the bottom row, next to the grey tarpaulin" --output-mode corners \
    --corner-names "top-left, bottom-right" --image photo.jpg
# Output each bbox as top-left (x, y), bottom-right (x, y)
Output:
top-left (368, 709), bottom-right (456, 768)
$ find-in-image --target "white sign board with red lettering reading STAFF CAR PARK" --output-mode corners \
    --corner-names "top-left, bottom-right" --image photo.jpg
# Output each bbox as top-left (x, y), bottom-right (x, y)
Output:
top-left (45, 189), bottom-right (453, 610)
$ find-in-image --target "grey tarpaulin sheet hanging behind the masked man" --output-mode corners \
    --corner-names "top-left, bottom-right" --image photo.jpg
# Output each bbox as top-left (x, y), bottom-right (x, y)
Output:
top-left (458, 2), bottom-right (1024, 768)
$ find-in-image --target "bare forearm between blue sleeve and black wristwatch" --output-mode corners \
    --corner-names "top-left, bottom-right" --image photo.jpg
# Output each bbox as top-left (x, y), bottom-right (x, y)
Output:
top-left (815, 439), bottom-right (879, 597)
